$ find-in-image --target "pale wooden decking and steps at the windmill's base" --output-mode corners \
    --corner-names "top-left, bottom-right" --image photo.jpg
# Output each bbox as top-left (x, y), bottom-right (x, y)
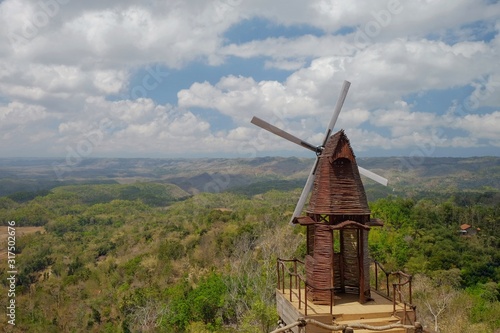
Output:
top-left (276, 289), bottom-right (408, 333)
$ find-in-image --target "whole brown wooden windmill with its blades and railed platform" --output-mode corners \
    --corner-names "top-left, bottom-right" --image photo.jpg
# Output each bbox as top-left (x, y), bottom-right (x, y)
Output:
top-left (252, 81), bottom-right (417, 326)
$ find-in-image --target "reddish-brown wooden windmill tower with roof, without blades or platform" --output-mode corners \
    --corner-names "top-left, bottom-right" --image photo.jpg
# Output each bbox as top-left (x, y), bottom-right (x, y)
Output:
top-left (293, 131), bottom-right (380, 304)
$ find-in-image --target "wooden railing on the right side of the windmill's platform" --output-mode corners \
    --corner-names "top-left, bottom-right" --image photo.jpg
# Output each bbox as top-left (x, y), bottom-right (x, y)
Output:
top-left (373, 260), bottom-right (416, 324)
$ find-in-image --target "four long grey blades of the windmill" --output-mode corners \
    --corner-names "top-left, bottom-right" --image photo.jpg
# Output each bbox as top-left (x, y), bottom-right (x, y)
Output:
top-left (251, 81), bottom-right (388, 223)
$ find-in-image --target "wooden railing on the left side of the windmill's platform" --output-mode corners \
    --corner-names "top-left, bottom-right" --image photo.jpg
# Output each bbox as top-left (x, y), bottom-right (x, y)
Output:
top-left (276, 258), bottom-right (334, 316)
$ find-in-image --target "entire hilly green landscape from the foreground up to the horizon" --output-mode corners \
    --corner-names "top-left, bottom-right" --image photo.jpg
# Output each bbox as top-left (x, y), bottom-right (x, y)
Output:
top-left (0, 157), bottom-right (500, 333)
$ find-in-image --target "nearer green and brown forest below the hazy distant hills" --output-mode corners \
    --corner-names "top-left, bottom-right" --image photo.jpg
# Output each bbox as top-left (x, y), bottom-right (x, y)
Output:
top-left (0, 182), bottom-right (500, 333)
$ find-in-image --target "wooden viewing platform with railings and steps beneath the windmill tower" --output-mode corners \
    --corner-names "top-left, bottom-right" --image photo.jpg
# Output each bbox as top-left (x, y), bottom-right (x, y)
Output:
top-left (276, 259), bottom-right (416, 333)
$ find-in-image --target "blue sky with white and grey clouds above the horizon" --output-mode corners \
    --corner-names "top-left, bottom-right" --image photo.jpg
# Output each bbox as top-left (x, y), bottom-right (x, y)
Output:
top-left (0, 0), bottom-right (500, 158)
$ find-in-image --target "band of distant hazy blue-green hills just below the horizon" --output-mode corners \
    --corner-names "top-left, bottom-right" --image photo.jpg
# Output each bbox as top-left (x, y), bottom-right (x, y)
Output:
top-left (0, 157), bottom-right (500, 200)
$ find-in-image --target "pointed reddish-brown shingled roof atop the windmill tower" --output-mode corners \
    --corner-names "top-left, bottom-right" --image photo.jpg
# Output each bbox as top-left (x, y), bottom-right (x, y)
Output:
top-left (306, 130), bottom-right (370, 215)
